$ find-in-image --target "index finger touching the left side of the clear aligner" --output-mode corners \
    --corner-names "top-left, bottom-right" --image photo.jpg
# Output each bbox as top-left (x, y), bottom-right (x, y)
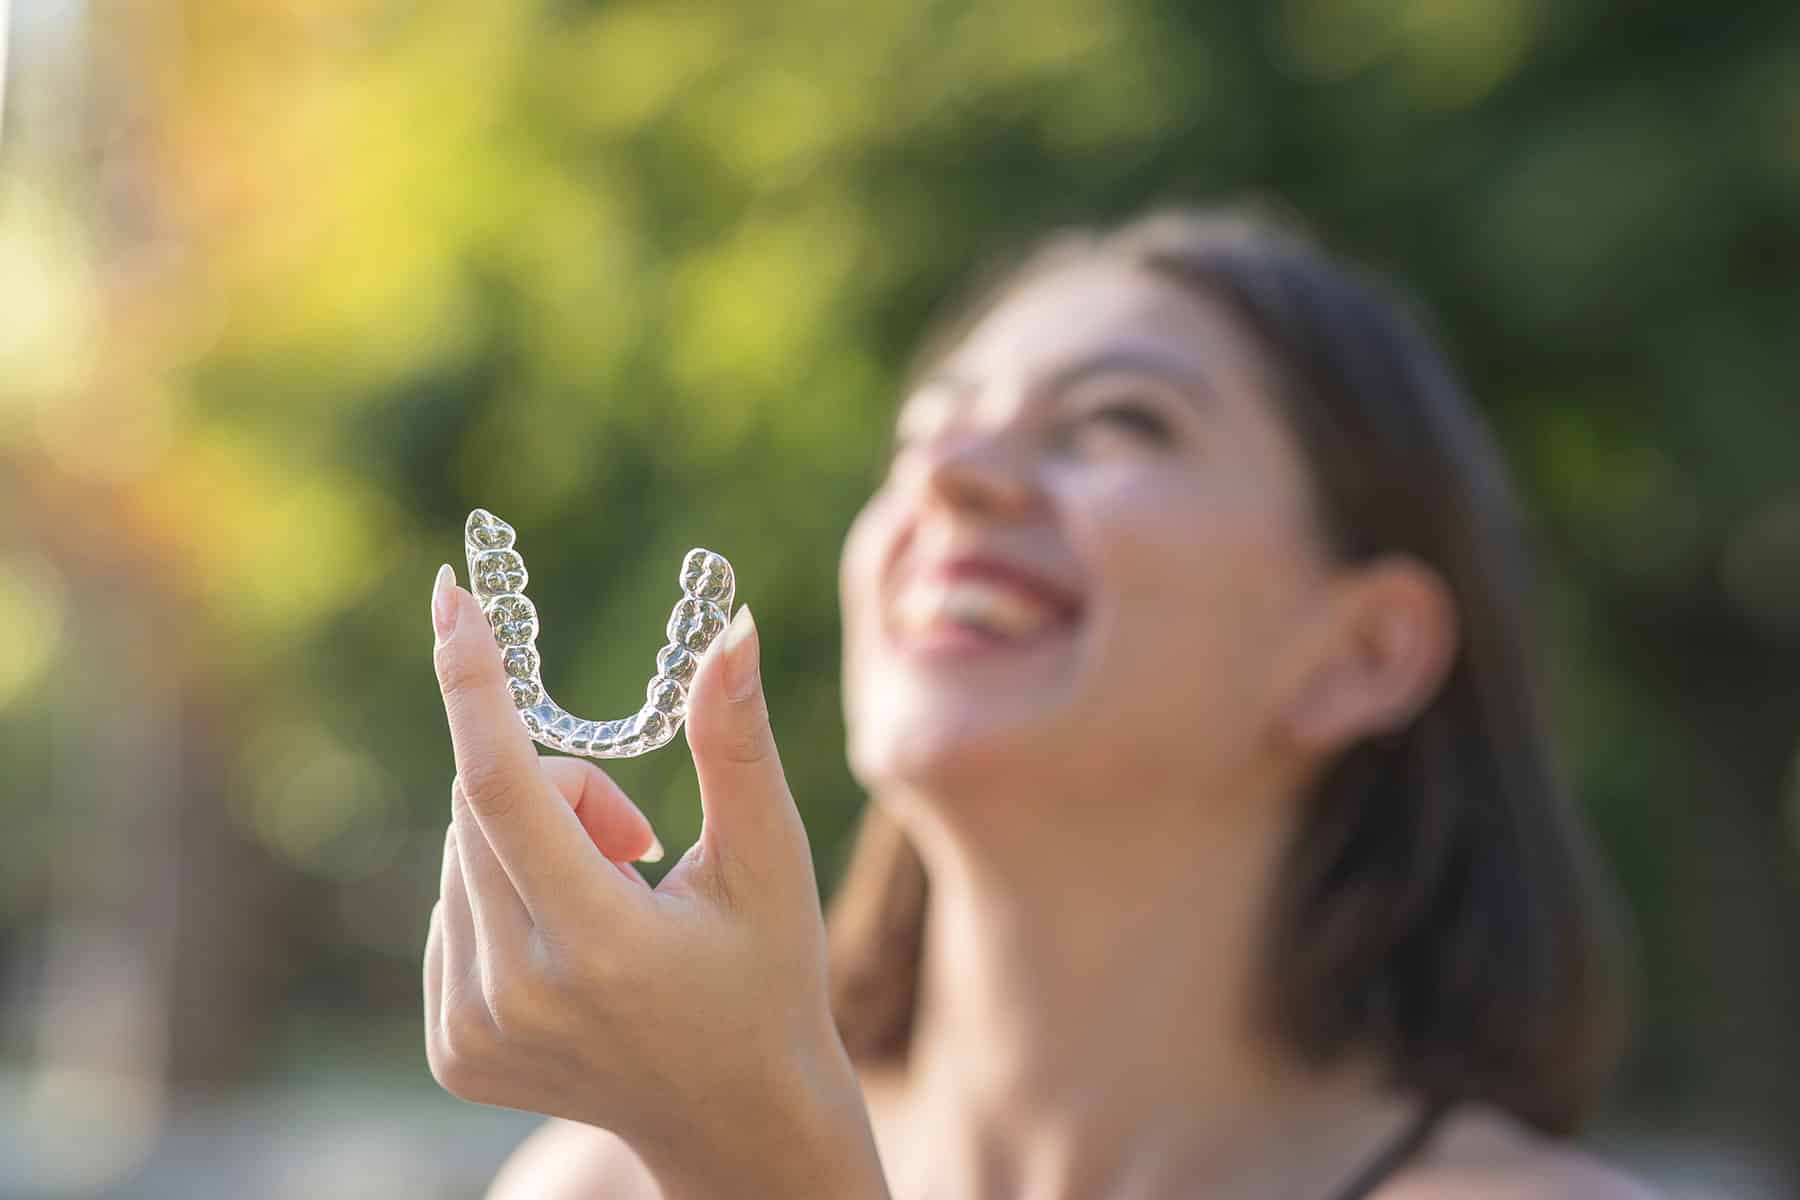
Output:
top-left (432, 563), bottom-right (625, 923)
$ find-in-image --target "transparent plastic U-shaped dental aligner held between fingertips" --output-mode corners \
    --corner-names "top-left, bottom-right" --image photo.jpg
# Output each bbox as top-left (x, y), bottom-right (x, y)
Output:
top-left (463, 509), bottom-right (736, 757)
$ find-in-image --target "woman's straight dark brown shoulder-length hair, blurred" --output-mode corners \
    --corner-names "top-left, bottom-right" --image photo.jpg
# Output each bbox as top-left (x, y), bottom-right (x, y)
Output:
top-left (828, 209), bottom-right (1629, 1133)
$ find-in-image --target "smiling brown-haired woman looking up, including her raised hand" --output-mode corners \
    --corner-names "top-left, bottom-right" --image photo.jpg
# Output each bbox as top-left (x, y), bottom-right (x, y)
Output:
top-left (427, 214), bottom-right (1645, 1200)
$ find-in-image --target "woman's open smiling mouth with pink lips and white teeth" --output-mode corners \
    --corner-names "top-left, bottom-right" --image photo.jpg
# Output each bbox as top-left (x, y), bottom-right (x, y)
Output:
top-left (889, 556), bottom-right (1080, 649)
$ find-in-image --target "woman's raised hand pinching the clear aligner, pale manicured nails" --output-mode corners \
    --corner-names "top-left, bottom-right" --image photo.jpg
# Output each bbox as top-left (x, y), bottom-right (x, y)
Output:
top-left (425, 567), bottom-right (886, 1196)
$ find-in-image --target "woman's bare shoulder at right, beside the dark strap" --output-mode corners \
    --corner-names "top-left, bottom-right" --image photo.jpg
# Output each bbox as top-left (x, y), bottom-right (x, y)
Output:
top-left (1377, 1105), bottom-right (1661, 1200)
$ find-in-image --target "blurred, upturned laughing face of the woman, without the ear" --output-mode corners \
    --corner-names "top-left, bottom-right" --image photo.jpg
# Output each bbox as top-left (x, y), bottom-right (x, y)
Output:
top-left (841, 261), bottom-right (1325, 813)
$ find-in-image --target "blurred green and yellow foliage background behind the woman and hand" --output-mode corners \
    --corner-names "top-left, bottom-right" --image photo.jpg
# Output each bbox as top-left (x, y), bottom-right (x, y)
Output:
top-left (0, 0), bottom-right (1800, 1198)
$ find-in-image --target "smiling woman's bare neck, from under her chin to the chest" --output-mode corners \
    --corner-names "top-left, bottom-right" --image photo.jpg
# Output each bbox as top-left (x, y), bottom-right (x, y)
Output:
top-left (882, 770), bottom-right (1411, 1198)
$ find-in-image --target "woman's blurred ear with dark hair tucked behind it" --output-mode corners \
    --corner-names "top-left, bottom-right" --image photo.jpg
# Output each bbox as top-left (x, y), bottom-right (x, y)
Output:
top-left (1282, 554), bottom-right (1460, 754)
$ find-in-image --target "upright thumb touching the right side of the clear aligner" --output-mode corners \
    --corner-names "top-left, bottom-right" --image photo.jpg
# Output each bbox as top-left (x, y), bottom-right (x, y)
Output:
top-left (688, 604), bottom-right (817, 903)
